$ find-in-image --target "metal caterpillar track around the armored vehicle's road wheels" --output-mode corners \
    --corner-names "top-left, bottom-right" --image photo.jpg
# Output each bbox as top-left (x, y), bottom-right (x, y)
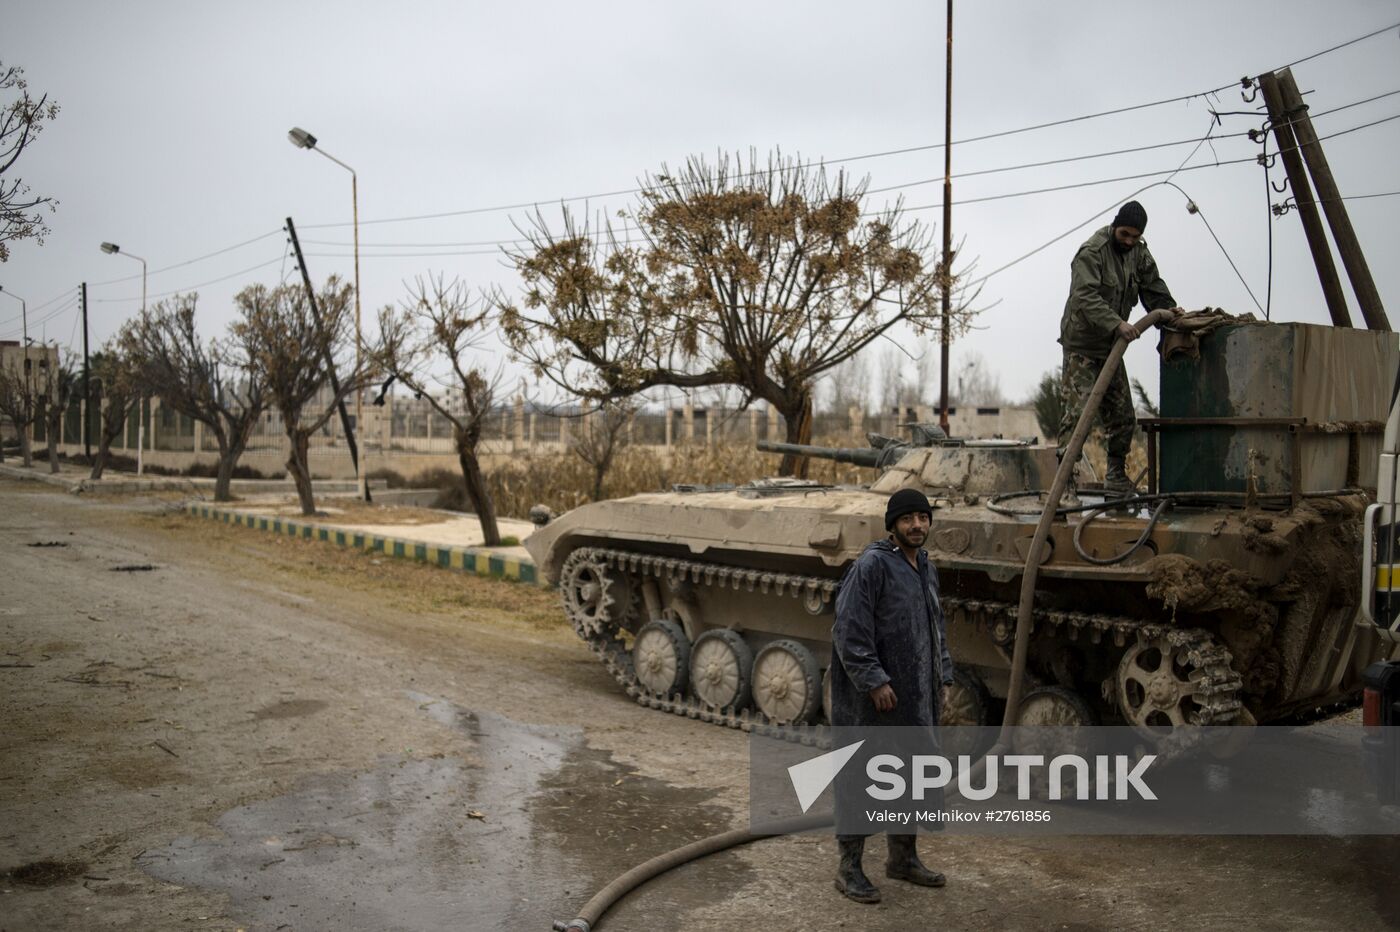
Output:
top-left (570, 547), bottom-right (1242, 746)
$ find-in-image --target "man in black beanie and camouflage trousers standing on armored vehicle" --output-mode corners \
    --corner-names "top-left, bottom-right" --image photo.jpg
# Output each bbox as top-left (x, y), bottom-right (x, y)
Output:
top-left (1058, 200), bottom-right (1182, 494)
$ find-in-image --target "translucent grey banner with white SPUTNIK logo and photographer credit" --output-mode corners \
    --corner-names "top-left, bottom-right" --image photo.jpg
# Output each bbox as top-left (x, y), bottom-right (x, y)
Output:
top-left (749, 722), bottom-right (1400, 835)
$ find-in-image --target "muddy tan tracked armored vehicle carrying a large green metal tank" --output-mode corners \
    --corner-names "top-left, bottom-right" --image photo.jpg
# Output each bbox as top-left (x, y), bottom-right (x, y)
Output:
top-left (526, 323), bottom-right (1400, 736)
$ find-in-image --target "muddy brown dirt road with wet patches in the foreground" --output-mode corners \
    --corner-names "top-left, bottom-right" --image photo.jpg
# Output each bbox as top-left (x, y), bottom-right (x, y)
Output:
top-left (0, 480), bottom-right (1400, 932)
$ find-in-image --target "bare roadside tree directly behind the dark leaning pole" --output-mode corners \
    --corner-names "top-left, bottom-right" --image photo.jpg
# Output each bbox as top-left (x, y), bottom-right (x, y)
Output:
top-left (231, 276), bottom-right (370, 515)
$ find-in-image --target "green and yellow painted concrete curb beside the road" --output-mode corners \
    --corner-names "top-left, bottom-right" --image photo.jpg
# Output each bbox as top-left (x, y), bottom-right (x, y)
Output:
top-left (185, 502), bottom-right (543, 585)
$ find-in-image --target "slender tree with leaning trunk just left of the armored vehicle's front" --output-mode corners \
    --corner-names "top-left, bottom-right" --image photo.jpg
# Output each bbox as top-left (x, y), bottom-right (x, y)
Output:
top-left (379, 276), bottom-right (501, 547)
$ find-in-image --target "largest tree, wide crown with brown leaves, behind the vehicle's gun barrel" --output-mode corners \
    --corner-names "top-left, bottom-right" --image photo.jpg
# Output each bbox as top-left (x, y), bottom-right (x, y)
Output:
top-left (501, 154), bottom-right (970, 474)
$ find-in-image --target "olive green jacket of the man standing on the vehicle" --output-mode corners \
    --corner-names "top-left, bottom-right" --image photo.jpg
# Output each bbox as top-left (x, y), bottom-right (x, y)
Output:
top-left (1060, 227), bottom-right (1176, 360)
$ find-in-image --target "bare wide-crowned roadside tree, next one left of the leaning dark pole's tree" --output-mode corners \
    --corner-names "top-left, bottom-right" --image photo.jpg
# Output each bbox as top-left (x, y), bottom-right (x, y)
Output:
top-left (115, 292), bottom-right (267, 501)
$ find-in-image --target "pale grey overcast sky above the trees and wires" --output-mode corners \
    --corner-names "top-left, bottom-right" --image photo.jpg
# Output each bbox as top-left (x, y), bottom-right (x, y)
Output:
top-left (0, 0), bottom-right (1400, 411)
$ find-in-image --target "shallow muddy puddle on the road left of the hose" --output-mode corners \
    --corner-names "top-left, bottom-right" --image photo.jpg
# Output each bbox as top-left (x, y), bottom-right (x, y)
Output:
top-left (139, 693), bottom-right (749, 931)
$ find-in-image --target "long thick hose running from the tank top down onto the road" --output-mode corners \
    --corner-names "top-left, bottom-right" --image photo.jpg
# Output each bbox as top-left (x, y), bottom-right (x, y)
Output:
top-left (553, 311), bottom-right (1172, 932)
